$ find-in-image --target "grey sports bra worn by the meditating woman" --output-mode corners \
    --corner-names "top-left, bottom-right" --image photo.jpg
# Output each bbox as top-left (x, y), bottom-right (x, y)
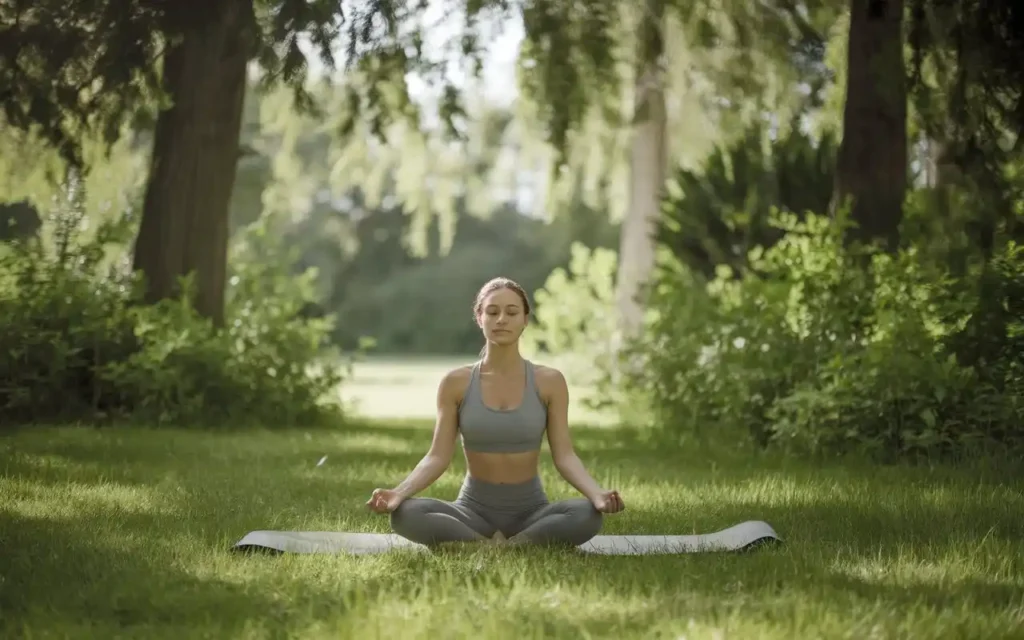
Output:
top-left (459, 360), bottom-right (548, 453)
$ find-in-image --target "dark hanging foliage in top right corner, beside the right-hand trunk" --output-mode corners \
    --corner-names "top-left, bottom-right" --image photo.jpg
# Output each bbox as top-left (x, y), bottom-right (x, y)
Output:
top-left (907, 0), bottom-right (1024, 268)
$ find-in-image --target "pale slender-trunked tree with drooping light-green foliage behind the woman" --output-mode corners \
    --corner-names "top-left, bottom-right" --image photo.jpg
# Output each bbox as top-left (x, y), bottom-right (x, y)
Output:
top-left (317, 0), bottom-right (835, 350)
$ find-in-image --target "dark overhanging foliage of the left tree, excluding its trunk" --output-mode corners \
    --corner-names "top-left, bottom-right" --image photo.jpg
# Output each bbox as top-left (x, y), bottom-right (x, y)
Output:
top-left (0, 0), bottom-right (616, 165)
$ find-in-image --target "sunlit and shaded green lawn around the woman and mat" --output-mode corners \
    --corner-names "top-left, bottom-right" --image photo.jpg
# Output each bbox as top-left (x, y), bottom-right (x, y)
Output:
top-left (0, 422), bottom-right (1024, 640)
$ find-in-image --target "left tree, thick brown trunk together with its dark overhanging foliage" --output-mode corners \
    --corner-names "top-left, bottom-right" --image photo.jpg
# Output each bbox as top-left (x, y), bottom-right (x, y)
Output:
top-left (0, 0), bottom-right (614, 321)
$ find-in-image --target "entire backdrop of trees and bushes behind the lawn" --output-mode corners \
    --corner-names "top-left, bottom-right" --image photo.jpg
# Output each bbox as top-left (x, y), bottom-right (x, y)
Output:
top-left (0, 0), bottom-right (1024, 458)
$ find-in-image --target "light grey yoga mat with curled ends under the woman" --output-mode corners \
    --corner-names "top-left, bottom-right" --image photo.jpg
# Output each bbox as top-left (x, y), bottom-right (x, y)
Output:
top-left (233, 520), bottom-right (781, 555)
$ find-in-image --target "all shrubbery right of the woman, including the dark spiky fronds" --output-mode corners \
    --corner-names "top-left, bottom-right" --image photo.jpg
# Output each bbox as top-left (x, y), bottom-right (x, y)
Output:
top-left (538, 117), bottom-right (1024, 460)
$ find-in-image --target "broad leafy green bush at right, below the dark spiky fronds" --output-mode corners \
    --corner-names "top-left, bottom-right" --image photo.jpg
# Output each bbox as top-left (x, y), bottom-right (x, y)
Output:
top-left (628, 209), bottom-right (1024, 459)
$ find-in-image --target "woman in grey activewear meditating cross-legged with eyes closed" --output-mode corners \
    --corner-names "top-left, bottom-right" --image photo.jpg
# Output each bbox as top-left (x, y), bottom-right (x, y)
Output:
top-left (367, 278), bottom-right (625, 546)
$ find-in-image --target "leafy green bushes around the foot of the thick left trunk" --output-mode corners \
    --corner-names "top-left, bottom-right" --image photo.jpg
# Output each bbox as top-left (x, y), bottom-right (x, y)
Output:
top-left (0, 182), bottom-right (342, 426)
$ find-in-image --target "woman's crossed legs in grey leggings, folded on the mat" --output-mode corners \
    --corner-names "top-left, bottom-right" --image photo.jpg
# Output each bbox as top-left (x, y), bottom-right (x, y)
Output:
top-left (391, 498), bottom-right (603, 546)
